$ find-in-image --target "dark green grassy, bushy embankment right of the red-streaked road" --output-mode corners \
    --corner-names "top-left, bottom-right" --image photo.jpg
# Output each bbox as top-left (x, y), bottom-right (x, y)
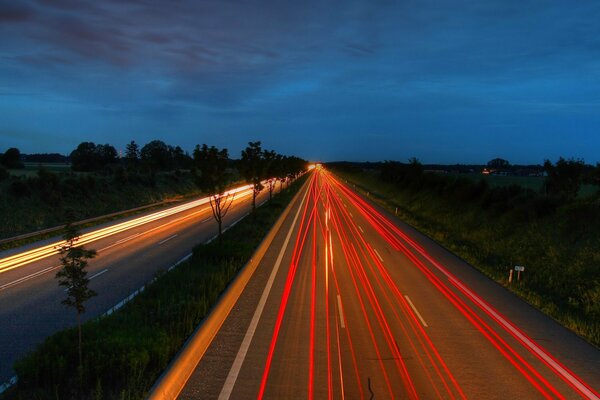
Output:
top-left (332, 160), bottom-right (600, 345)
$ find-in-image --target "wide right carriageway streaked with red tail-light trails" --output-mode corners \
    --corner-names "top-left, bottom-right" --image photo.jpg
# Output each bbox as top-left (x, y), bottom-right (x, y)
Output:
top-left (179, 169), bottom-right (600, 399)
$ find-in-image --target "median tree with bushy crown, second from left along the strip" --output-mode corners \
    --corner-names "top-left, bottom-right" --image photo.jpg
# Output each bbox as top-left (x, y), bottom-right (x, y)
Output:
top-left (194, 144), bottom-right (235, 242)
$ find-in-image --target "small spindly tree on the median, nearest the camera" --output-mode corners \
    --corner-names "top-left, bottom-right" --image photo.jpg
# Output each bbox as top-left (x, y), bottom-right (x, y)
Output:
top-left (56, 223), bottom-right (96, 368)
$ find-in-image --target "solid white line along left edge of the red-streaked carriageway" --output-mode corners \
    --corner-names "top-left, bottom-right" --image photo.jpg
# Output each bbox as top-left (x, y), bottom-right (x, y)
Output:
top-left (219, 183), bottom-right (308, 400)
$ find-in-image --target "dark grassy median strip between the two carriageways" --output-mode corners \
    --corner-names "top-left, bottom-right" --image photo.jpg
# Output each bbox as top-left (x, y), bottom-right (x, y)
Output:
top-left (0, 177), bottom-right (306, 400)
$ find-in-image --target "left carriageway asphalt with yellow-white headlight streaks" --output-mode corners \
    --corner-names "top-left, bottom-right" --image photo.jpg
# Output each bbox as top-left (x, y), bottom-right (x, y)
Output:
top-left (0, 183), bottom-right (278, 383)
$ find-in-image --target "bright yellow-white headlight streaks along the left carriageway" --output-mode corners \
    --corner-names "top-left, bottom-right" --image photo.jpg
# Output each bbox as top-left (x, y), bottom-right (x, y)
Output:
top-left (0, 185), bottom-right (252, 274)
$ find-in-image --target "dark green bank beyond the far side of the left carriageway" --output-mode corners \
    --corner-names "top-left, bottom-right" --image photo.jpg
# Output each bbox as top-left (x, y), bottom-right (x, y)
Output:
top-left (0, 169), bottom-right (200, 241)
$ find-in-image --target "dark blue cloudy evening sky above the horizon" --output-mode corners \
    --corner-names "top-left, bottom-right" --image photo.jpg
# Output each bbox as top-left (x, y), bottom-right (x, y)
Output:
top-left (0, 0), bottom-right (600, 163)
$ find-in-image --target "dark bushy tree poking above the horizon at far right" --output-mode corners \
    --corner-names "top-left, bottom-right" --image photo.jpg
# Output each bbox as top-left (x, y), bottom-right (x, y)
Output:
top-left (544, 157), bottom-right (585, 201)
